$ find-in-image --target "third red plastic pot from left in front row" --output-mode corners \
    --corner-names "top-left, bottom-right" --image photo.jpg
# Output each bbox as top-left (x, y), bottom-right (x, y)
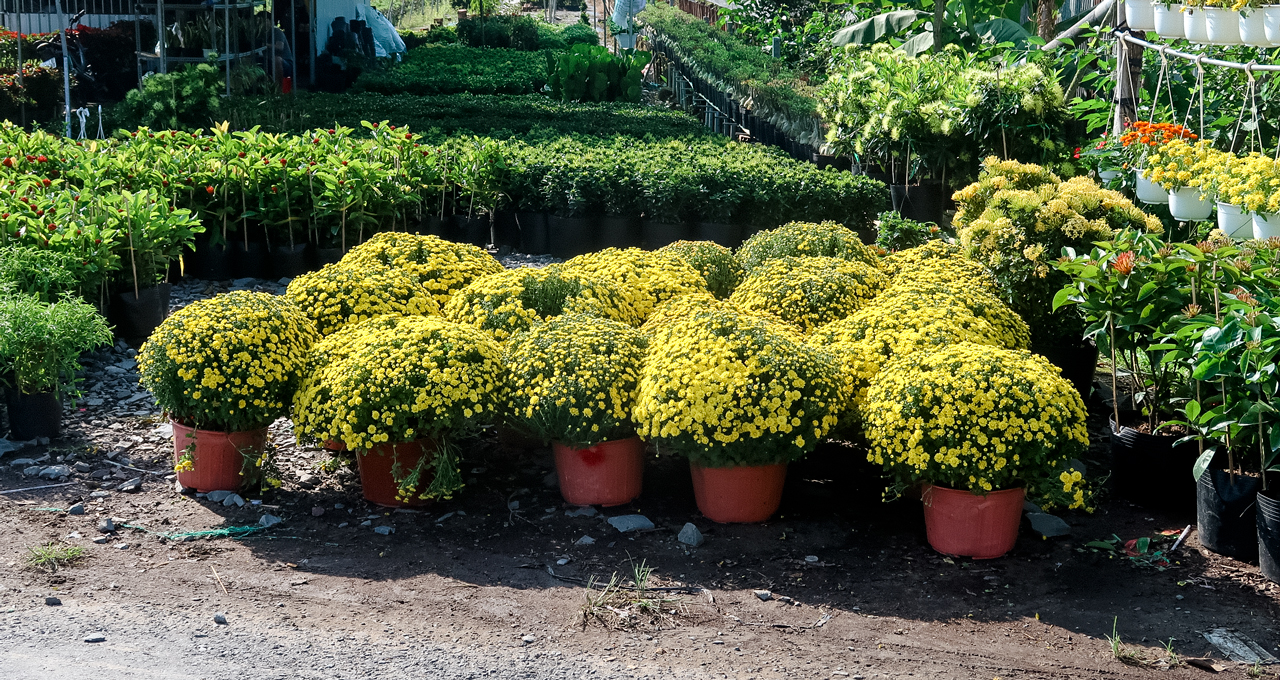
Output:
top-left (552, 437), bottom-right (644, 506)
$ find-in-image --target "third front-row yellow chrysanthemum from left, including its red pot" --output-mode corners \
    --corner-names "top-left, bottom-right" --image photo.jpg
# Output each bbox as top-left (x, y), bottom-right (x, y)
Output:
top-left (502, 314), bottom-right (648, 506)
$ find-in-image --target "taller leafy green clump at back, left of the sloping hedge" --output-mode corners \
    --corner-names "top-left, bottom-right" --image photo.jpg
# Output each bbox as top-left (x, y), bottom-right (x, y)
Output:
top-left (547, 45), bottom-right (653, 104)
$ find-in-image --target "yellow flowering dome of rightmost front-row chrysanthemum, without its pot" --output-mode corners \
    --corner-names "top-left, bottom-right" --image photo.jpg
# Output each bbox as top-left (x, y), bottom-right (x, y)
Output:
top-left (863, 342), bottom-right (1089, 510)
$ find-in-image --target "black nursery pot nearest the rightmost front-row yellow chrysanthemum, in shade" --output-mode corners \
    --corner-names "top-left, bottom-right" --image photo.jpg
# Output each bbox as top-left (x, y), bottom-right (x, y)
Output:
top-left (1111, 420), bottom-right (1199, 514)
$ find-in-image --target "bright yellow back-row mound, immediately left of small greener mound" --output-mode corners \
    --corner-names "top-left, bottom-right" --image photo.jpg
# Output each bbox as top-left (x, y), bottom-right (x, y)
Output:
top-left (563, 248), bottom-right (707, 325)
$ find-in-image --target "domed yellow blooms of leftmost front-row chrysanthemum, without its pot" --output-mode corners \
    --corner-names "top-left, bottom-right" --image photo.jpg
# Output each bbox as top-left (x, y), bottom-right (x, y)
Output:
top-left (138, 291), bottom-right (319, 432)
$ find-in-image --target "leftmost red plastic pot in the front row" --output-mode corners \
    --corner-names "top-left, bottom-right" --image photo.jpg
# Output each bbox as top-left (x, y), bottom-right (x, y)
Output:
top-left (173, 421), bottom-right (266, 493)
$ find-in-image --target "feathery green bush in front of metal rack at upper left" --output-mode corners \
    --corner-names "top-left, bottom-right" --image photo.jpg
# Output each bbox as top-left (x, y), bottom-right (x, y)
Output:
top-left (115, 64), bottom-right (225, 129)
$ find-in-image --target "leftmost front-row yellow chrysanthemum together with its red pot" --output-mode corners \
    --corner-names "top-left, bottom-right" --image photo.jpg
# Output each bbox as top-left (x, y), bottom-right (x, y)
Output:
top-left (138, 291), bottom-right (319, 492)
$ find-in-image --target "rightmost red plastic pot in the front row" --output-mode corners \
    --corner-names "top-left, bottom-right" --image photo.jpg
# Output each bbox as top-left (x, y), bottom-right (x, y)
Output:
top-left (920, 484), bottom-right (1025, 560)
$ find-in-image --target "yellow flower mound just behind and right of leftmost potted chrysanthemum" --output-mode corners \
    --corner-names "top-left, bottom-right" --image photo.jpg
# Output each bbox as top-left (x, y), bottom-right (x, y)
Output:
top-left (285, 265), bottom-right (440, 336)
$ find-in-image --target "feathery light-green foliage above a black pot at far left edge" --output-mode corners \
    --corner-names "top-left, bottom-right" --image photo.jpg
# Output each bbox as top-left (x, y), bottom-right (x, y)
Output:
top-left (0, 295), bottom-right (111, 394)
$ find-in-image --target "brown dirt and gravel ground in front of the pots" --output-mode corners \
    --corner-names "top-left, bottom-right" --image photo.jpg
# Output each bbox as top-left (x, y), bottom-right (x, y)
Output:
top-left (0, 379), bottom-right (1280, 680)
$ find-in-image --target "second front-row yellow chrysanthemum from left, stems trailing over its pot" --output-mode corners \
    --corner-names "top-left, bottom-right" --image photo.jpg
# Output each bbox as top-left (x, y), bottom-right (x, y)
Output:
top-left (293, 315), bottom-right (503, 505)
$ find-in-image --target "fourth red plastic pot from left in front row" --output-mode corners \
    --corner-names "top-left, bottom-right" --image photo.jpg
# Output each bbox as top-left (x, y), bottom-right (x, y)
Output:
top-left (689, 462), bottom-right (787, 524)
